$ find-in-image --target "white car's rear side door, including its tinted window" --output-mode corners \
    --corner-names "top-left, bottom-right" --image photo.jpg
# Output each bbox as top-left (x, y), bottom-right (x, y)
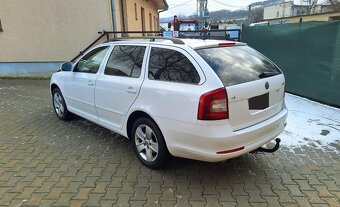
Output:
top-left (95, 45), bottom-right (148, 130)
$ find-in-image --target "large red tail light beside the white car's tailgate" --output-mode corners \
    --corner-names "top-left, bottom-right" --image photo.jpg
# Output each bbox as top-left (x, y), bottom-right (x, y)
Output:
top-left (197, 88), bottom-right (229, 120)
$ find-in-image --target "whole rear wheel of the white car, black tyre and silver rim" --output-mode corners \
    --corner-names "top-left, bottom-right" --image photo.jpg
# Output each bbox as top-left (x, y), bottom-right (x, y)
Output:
top-left (130, 117), bottom-right (170, 169)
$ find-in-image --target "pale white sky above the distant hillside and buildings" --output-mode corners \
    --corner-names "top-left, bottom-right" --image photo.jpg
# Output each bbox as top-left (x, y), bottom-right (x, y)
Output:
top-left (160, 0), bottom-right (302, 18)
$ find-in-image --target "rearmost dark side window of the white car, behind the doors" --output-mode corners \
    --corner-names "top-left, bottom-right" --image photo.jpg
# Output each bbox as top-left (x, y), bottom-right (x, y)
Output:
top-left (148, 47), bottom-right (200, 84)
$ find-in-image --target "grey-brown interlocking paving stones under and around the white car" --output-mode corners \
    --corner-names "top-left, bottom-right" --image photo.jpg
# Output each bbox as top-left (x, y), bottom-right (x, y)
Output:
top-left (0, 80), bottom-right (340, 206)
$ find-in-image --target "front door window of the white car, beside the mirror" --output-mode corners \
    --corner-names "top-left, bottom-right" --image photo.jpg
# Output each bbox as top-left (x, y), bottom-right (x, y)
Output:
top-left (74, 47), bottom-right (109, 73)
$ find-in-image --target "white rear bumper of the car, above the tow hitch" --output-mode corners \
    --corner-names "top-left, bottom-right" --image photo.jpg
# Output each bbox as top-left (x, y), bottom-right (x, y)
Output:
top-left (157, 107), bottom-right (288, 162)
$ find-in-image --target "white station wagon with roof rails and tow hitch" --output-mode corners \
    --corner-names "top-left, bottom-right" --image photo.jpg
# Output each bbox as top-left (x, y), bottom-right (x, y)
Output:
top-left (50, 37), bottom-right (287, 168)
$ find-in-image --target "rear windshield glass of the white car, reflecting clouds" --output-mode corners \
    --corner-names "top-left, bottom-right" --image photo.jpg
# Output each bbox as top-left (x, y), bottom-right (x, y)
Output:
top-left (196, 46), bottom-right (281, 86)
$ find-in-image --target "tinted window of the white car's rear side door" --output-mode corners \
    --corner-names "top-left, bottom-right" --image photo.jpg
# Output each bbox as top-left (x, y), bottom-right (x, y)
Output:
top-left (104, 45), bottom-right (146, 78)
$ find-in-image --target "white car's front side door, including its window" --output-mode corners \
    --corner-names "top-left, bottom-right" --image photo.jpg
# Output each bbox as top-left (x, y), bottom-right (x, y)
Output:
top-left (64, 46), bottom-right (109, 121)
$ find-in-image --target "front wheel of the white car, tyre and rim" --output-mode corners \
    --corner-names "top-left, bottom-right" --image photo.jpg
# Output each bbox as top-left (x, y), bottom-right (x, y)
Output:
top-left (52, 88), bottom-right (72, 121)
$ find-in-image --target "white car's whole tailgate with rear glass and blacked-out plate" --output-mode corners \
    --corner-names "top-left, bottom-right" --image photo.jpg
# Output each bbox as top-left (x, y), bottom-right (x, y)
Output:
top-left (196, 46), bottom-right (285, 131)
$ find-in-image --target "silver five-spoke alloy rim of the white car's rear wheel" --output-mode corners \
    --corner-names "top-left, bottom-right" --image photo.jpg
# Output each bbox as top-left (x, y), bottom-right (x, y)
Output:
top-left (135, 125), bottom-right (158, 162)
